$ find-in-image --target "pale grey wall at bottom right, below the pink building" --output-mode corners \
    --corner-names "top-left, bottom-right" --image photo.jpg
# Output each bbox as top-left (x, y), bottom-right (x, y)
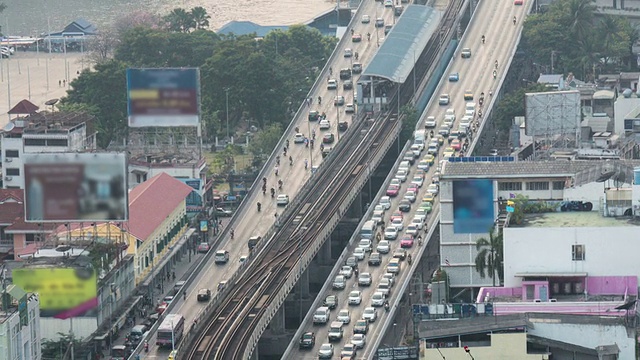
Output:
top-left (527, 318), bottom-right (636, 360)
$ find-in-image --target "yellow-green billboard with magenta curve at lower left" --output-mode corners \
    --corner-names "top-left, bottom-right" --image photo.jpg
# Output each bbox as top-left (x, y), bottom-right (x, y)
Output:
top-left (12, 268), bottom-right (98, 319)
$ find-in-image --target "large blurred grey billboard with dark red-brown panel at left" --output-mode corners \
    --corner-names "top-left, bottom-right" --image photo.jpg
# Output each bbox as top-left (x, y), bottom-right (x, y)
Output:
top-left (23, 153), bottom-right (128, 222)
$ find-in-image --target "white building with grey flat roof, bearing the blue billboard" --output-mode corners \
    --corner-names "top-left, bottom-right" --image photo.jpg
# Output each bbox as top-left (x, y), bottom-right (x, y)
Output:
top-left (439, 161), bottom-right (640, 301)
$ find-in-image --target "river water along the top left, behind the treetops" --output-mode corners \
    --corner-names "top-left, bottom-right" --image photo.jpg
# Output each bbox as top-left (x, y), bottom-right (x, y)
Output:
top-left (0, 0), bottom-right (335, 36)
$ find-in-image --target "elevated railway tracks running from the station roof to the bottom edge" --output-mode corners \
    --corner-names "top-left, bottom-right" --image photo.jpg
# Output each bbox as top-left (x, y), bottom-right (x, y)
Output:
top-left (186, 95), bottom-right (398, 360)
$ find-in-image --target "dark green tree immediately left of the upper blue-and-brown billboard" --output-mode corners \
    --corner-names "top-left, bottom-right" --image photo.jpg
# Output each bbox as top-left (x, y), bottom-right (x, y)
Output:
top-left (61, 60), bottom-right (127, 148)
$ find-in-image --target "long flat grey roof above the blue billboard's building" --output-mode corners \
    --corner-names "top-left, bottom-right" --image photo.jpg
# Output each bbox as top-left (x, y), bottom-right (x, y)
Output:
top-left (442, 160), bottom-right (640, 180)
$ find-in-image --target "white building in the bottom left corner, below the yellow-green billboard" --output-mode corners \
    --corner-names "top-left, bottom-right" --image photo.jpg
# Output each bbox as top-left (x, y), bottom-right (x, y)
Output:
top-left (0, 285), bottom-right (42, 360)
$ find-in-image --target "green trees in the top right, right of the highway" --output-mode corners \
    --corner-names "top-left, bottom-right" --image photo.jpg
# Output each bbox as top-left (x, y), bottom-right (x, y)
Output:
top-left (521, 0), bottom-right (637, 80)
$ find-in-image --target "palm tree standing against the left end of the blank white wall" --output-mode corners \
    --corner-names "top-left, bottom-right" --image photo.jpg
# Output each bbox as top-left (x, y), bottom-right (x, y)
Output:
top-left (476, 225), bottom-right (504, 286)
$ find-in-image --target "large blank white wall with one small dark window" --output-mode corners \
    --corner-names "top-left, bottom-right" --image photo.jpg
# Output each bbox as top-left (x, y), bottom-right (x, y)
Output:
top-left (504, 226), bottom-right (640, 287)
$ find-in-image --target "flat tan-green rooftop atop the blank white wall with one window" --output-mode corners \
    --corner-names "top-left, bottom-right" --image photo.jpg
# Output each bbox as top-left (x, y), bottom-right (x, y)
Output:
top-left (518, 211), bottom-right (640, 227)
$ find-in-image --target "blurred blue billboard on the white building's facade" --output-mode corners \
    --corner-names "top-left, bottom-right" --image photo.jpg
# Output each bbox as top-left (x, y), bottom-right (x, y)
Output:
top-left (453, 179), bottom-right (495, 234)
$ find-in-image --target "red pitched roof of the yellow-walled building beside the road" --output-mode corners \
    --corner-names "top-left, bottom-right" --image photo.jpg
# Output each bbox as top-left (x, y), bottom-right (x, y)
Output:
top-left (129, 173), bottom-right (193, 241)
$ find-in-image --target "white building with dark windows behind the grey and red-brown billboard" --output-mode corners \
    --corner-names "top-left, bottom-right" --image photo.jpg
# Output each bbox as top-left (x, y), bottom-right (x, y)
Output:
top-left (0, 112), bottom-right (96, 189)
